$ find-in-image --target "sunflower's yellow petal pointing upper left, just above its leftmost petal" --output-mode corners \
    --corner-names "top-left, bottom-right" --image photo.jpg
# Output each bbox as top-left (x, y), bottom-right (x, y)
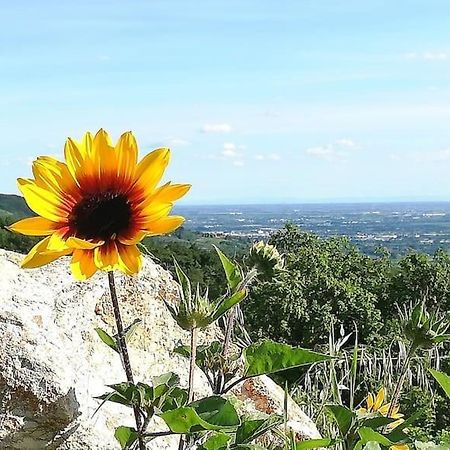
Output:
top-left (17, 178), bottom-right (68, 222)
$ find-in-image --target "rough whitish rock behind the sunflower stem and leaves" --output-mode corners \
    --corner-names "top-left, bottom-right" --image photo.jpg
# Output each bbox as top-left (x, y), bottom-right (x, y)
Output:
top-left (0, 250), bottom-right (318, 450)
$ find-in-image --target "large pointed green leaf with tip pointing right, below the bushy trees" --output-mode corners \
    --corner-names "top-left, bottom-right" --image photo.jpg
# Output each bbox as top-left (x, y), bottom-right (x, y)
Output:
top-left (244, 340), bottom-right (331, 378)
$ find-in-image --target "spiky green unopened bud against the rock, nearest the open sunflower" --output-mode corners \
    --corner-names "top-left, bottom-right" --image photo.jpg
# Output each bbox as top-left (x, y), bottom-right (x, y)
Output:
top-left (165, 261), bottom-right (247, 331)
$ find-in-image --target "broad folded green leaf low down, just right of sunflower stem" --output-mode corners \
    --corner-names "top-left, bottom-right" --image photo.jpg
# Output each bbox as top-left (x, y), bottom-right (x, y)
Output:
top-left (160, 396), bottom-right (240, 433)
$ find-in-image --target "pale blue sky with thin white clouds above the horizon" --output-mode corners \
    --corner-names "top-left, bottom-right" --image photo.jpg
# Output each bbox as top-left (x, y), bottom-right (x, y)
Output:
top-left (0, 0), bottom-right (450, 204)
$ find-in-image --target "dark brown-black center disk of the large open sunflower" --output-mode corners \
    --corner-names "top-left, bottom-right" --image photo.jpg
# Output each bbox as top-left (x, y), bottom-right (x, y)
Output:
top-left (69, 192), bottom-right (131, 241)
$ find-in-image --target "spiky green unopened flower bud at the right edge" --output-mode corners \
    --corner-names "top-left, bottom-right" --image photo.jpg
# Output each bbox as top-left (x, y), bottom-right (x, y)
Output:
top-left (402, 303), bottom-right (450, 349)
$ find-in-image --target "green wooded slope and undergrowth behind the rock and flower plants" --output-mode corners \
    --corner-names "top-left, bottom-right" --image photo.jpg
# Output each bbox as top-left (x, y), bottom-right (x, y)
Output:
top-left (0, 196), bottom-right (450, 444)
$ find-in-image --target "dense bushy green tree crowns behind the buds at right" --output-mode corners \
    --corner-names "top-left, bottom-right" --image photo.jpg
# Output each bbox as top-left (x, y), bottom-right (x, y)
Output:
top-left (243, 225), bottom-right (450, 347)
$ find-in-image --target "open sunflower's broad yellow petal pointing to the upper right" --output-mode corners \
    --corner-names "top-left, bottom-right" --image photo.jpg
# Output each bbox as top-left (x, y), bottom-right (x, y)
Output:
top-left (136, 148), bottom-right (170, 197)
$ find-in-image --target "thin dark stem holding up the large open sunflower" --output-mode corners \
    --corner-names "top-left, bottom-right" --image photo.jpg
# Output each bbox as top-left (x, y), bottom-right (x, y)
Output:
top-left (108, 271), bottom-right (145, 450)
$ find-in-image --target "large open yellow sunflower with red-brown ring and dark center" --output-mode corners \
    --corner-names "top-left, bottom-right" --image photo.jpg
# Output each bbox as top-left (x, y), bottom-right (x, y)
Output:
top-left (9, 130), bottom-right (190, 280)
